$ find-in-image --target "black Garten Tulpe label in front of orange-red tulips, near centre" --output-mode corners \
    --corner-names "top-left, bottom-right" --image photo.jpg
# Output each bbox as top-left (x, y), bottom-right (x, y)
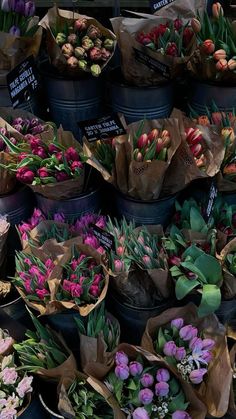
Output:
top-left (78, 114), bottom-right (126, 142)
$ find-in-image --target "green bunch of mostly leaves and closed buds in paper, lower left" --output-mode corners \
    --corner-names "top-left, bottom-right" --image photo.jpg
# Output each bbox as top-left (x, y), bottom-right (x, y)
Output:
top-left (13, 311), bottom-right (77, 382)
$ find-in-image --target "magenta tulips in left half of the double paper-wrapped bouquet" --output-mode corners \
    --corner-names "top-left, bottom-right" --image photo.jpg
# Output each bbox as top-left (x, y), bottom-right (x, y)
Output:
top-left (14, 252), bottom-right (55, 302)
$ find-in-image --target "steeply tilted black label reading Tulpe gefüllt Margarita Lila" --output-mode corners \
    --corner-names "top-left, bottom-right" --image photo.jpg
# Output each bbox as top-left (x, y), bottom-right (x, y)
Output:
top-left (7, 55), bottom-right (39, 108)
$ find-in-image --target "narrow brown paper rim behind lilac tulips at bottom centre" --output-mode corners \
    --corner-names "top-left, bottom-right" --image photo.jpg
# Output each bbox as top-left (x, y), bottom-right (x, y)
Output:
top-left (86, 343), bottom-right (206, 419)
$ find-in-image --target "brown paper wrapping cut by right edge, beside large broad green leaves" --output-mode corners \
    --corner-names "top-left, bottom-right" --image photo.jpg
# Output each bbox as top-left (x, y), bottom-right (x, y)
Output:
top-left (219, 238), bottom-right (236, 300)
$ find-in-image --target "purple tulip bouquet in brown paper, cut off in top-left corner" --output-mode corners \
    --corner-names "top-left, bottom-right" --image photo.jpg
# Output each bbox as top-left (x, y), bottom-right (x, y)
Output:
top-left (0, 0), bottom-right (42, 85)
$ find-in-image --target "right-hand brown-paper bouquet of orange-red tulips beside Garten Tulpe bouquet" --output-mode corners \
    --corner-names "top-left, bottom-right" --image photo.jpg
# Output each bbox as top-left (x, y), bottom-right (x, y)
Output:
top-left (163, 109), bottom-right (225, 194)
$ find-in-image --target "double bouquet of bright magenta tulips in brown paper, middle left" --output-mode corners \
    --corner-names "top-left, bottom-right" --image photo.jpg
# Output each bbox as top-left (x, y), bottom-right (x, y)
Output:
top-left (15, 239), bottom-right (109, 316)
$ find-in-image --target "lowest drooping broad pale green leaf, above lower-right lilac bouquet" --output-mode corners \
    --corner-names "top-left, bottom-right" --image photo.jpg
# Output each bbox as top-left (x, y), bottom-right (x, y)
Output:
top-left (198, 284), bottom-right (221, 317)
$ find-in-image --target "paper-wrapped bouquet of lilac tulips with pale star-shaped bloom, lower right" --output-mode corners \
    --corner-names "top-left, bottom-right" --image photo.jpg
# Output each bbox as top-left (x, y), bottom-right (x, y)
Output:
top-left (141, 304), bottom-right (232, 417)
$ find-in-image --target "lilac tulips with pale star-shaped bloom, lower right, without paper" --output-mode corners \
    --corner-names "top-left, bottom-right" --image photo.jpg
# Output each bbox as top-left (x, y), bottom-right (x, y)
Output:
top-left (154, 318), bottom-right (215, 385)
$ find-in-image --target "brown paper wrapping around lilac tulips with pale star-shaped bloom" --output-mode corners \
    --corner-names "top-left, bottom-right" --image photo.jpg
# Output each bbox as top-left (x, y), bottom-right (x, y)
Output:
top-left (141, 303), bottom-right (232, 417)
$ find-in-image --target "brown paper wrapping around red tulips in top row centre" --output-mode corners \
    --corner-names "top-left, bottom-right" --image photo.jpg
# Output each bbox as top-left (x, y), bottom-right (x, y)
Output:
top-left (110, 15), bottom-right (193, 86)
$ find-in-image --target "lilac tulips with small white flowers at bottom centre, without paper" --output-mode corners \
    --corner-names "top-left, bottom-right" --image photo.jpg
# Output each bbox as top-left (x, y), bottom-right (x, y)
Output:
top-left (105, 351), bottom-right (191, 419)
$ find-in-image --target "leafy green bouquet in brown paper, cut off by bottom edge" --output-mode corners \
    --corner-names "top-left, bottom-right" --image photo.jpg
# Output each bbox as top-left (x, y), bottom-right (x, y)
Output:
top-left (58, 371), bottom-right (122, 419)
